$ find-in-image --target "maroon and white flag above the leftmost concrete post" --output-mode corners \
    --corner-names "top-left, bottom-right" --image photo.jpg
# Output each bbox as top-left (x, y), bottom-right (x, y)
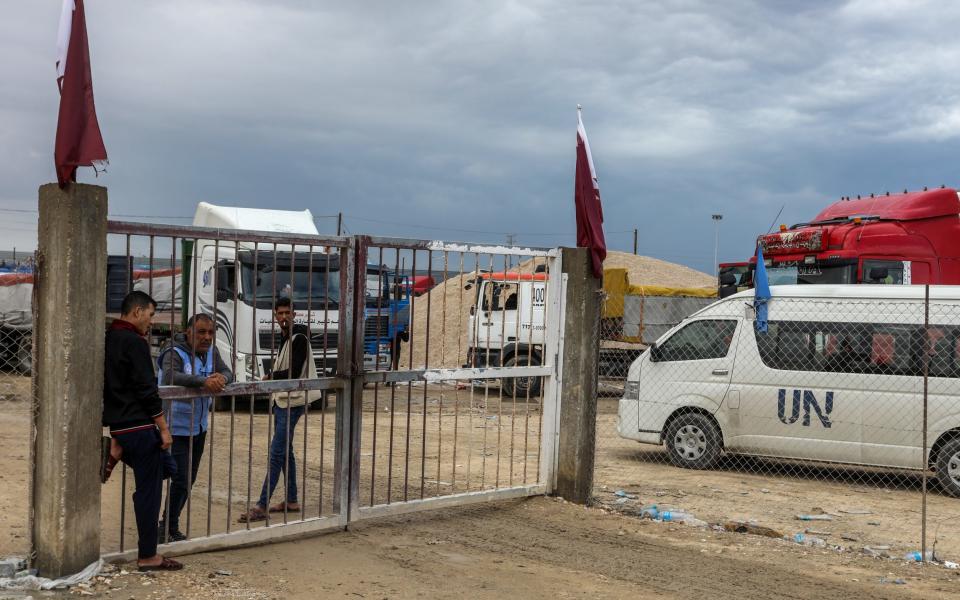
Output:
top-left (53, 0), bottom-right (107, 188)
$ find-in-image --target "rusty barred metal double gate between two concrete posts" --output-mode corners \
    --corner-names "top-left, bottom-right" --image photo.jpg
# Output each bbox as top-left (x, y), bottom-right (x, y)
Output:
top-left (101, 221), bottom-right (562, 558)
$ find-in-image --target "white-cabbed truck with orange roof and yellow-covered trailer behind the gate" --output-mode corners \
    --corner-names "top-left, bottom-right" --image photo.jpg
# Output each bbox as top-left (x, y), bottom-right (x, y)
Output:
top-left (464, 269), bottom-right (717, 397)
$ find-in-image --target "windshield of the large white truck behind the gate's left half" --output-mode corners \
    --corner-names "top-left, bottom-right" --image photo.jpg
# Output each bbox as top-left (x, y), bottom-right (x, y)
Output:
top-left (241, 262), bottom-right (340, 310)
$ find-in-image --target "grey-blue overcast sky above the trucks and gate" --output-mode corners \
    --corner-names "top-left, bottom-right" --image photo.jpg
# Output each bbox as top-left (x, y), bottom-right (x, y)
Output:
top-left (0, 0), bottom-right (960, 272)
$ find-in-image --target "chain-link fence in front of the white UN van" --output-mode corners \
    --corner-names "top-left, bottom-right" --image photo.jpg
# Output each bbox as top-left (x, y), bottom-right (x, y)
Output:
top-left (595, 286), bottom-right (960, 561)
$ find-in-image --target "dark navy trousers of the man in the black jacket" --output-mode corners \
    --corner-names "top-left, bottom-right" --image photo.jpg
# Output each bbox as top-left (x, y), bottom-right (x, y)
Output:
top-left (116, 427), bottom-right (163, 558)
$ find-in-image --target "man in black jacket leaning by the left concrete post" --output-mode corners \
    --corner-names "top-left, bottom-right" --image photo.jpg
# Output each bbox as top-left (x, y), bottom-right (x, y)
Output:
top-left (103, 291), bottom-right (183, 571)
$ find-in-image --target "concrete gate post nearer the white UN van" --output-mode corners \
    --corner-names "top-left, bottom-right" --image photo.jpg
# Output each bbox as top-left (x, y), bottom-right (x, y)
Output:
top-left (556, 248), bottom-right (602, 504)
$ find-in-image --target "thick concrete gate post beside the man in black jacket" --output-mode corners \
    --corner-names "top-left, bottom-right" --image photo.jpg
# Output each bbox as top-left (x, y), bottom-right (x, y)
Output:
top-left (30, 183), bottom-right (107, 577)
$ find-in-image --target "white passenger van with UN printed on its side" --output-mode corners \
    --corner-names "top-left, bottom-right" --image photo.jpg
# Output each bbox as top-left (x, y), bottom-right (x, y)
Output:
top-left (618, 285), bottom-right (960, 496)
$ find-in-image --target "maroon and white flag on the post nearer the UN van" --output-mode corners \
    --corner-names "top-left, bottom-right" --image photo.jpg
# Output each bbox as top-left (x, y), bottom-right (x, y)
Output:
top-left (573, 106), bottom-right (607, 279)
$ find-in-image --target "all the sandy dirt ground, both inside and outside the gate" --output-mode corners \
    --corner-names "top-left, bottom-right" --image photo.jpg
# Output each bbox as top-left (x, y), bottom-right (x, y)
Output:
top-left (0, 376), bottom-right (960, 599)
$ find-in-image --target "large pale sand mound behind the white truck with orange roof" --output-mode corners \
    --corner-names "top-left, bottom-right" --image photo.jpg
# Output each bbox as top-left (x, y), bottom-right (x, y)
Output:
top-left (400, 252), bottom-right (716, 369)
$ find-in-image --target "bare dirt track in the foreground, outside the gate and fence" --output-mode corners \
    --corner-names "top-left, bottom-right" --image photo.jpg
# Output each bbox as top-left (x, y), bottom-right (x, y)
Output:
top-left (56, 498), bottom-right (960, 600)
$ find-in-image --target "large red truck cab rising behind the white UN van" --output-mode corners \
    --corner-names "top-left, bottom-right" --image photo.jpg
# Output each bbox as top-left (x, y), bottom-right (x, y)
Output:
top-left (750, 188), bottom-right (960, 285)
